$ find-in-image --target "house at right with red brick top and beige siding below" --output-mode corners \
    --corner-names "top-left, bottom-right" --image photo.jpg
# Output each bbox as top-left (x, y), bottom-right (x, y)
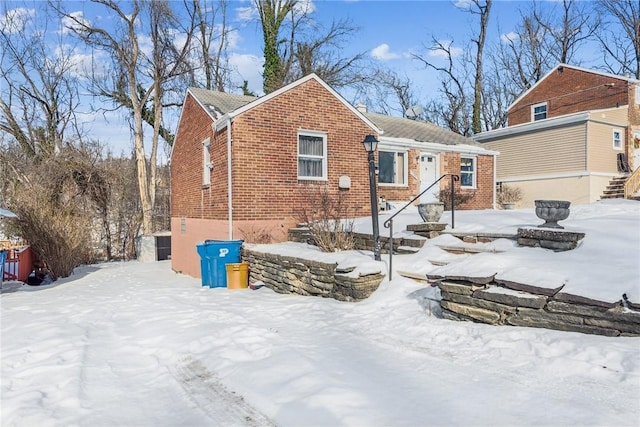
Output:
top-left (473, 64), bottom-right (640, 207)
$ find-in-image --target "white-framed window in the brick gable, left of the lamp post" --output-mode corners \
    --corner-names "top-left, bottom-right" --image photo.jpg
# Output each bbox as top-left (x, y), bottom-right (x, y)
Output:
top-left (298, 131), bottom-right (327, 180)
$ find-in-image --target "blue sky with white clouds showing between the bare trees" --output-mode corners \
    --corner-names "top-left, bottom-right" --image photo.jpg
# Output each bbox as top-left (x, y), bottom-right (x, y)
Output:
top-left (3, 0), bottom-right (597, 154)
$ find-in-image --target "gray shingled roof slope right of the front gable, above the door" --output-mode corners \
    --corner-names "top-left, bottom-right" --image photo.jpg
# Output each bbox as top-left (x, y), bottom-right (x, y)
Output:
top-left (365, 113), bottom-right (480, 146)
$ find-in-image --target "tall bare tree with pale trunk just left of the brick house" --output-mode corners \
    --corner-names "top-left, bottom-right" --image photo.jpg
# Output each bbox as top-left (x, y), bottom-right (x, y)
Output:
top-left (55, 0), bottom-right (195, 235)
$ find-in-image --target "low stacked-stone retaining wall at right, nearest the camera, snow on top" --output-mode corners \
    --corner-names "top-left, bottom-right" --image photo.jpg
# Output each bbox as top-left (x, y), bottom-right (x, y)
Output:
top-left (431, 277), bottom-right (640, 336)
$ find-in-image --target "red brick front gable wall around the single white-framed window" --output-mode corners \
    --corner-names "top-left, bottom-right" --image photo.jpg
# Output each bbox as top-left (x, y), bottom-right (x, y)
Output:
top-left (226, 80), bottom-right (372, 220)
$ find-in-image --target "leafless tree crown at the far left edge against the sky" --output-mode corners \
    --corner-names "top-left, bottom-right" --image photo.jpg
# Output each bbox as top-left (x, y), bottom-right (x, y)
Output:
top-left (0, 8), bottom-right (80, 160)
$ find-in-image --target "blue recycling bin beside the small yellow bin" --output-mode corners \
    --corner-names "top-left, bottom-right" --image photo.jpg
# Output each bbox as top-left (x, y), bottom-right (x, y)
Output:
top-left (196, 240), bottom-right (244, 288)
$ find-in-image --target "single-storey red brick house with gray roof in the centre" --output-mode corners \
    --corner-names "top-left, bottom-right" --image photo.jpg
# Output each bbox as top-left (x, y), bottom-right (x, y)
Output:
top-left (171, 74), bottom-right (495, 277)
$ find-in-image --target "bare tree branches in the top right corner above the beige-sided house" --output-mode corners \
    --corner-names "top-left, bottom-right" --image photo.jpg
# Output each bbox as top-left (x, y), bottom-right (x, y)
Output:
top-left (598, 0), bottom-right (640, 79)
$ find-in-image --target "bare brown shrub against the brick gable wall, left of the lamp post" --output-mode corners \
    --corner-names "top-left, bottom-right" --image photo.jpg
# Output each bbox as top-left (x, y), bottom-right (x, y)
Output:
top-left (297, 185), bottom-right (355, 252)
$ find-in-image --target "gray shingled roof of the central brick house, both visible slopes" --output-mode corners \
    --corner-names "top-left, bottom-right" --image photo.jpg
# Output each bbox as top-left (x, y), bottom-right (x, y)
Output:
top-left (189, 88), bottom-right (481, 146)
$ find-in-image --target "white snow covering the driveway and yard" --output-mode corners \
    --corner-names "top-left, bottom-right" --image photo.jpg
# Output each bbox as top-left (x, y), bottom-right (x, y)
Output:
top-left (0, 201), bottom-right (640, 426)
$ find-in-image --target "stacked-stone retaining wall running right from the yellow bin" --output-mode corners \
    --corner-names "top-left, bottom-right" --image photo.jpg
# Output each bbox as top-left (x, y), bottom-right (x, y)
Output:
top-left (242, 248), bottom-right (384, 301)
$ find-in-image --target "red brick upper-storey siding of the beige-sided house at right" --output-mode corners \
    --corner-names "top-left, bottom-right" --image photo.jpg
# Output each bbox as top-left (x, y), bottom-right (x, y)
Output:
top-left (508, 67), bottom-right (629, 126)
